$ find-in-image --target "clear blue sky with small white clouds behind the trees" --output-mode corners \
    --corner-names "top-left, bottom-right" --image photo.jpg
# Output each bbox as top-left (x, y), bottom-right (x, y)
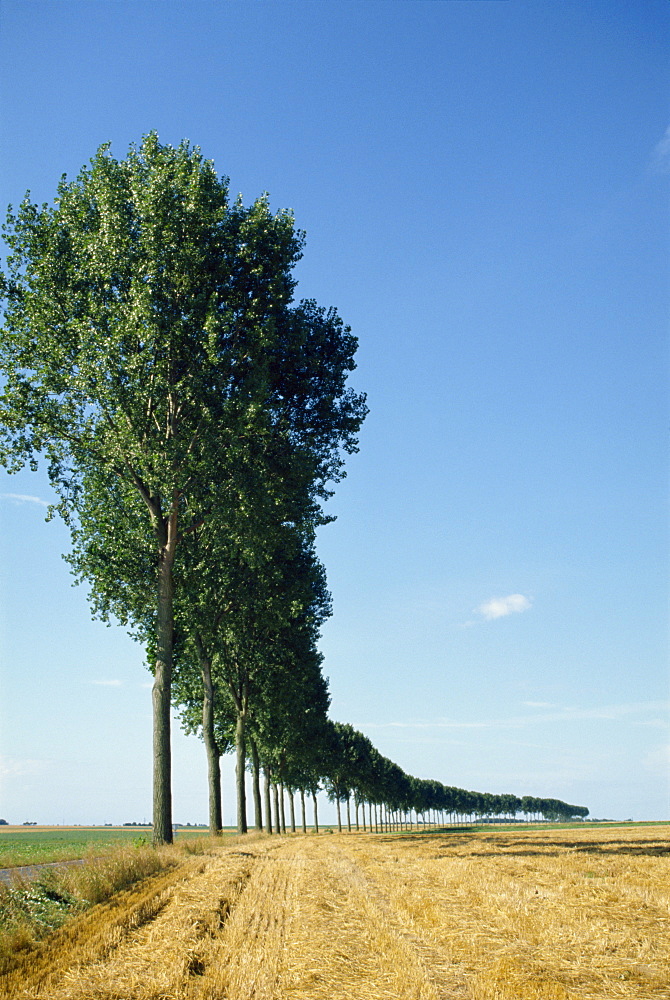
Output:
top-left (0, 0), bottom-right (670, 823)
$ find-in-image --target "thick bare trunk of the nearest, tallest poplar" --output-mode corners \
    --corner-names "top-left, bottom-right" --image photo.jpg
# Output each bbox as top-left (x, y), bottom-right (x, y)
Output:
top-left (151, 540), bottom-right (176, 846)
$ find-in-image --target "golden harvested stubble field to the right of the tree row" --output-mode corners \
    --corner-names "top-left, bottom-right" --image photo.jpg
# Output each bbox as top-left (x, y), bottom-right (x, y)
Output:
top-left (0, 825), bottom-right (670, 1000)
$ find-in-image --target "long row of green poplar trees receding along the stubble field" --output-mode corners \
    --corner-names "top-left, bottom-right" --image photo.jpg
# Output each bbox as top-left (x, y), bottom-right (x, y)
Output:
top-left (0, 133), bottom-right (588, 843)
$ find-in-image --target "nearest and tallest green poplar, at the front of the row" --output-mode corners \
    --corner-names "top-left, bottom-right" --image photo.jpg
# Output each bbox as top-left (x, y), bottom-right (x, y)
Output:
top-left (0, 133), bottom-right (365, 843)
